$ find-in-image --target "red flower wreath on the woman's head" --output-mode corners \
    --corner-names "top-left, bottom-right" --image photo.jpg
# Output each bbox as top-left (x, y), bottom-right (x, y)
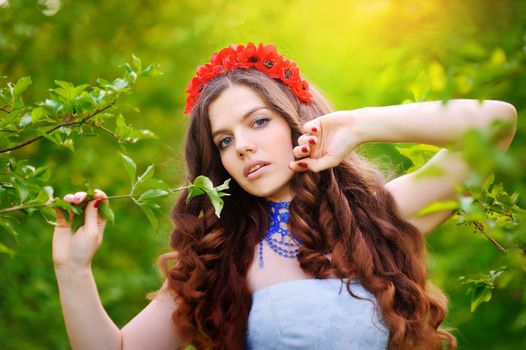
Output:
top-left (184, 42), bottom-right (312, 114)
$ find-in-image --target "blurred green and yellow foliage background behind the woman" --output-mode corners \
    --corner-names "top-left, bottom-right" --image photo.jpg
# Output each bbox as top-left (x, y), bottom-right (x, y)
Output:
top-left (0, 0), bottom-right (526, 349)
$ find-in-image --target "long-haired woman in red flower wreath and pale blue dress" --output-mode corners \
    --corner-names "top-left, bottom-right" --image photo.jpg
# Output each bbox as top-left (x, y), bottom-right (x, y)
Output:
top-left (53, 43), bottom-right (516, 349)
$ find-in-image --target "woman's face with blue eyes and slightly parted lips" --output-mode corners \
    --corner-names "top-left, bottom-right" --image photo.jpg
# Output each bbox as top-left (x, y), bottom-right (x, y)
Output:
top-left (208, 85), bottom-right (294, 202)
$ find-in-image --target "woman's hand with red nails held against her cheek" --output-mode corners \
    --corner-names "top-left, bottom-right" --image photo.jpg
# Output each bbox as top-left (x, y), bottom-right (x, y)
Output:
top-left (290, 111), bottom-right (360, 172)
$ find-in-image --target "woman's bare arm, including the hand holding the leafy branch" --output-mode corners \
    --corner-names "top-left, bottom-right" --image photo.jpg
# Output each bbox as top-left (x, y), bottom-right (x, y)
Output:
top-left (53, 190), bottom-right (182, 350)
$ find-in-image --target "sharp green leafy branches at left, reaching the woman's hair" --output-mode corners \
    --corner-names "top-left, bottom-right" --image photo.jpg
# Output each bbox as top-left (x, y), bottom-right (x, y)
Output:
top-left (0, 56), bottom-right (229, 256)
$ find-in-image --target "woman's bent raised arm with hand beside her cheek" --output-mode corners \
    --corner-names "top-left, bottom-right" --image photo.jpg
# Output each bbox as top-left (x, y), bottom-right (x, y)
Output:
top-left (291, 100), bottom-right (517, 233)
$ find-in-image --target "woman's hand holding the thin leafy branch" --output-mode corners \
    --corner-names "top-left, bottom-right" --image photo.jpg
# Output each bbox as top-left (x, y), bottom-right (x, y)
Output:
top-left (53, 190), bottom-right (107, 269)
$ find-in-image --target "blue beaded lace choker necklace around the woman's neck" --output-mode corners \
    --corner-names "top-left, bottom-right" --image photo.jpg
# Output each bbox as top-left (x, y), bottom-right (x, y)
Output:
top-left (259, 202), bottom-right (302, 269)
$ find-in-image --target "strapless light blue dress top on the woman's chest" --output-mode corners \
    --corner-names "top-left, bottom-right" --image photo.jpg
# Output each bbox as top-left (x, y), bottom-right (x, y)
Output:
top-left (247, 279), bottom-right (389, 350)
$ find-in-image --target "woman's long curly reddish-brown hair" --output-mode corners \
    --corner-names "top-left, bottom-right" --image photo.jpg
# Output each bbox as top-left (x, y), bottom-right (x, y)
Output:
top-left (160, 69), bottom-right (456, 350)
